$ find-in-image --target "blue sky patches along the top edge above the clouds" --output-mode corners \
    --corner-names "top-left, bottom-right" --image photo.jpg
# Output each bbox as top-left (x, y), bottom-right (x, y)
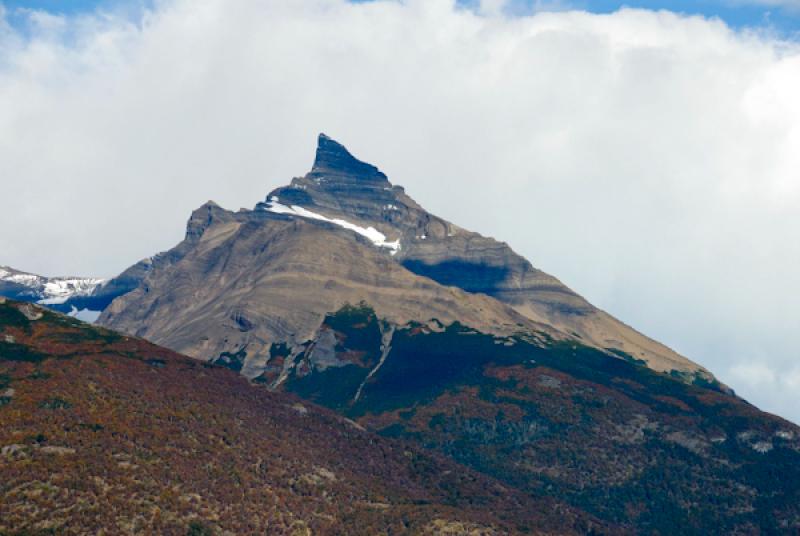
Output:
top-left (0, 0), bottom-right (800, 37)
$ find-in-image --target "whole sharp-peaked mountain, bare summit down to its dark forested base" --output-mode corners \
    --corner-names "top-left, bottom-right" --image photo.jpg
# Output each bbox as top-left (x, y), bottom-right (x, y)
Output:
top-left (90, 135), bottom-right (800, 534)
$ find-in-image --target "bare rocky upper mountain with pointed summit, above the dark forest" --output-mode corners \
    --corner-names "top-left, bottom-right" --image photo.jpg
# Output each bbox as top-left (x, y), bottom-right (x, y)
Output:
top-left (100, 134), bottom-right (713, 379)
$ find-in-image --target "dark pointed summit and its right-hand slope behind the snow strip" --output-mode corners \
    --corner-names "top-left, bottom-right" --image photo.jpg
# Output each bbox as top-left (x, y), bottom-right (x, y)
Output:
top-left (268, 134), bottom-right (712, 379)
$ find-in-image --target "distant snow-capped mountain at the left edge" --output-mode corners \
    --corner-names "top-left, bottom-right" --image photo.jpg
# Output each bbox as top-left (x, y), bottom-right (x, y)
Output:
top-left (0, 266), bottom-right (108, 321)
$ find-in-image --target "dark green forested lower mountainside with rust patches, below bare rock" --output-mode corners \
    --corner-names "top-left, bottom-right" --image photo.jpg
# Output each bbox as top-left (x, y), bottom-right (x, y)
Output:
top-left (276, 305), bottom-right (800, 535)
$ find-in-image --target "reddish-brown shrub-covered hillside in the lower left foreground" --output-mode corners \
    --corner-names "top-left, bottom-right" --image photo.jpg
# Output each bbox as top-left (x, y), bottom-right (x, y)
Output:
top-left (0, 298), bottom-right (604, 535)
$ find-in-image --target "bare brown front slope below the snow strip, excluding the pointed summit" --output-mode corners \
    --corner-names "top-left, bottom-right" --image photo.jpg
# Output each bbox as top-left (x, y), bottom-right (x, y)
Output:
top-left (100, 199), bottom-right (558, 377)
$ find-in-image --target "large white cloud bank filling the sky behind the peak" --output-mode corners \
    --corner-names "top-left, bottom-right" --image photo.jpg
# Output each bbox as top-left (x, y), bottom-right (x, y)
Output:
top-left (0, 0), bottom-right (800, 421)
